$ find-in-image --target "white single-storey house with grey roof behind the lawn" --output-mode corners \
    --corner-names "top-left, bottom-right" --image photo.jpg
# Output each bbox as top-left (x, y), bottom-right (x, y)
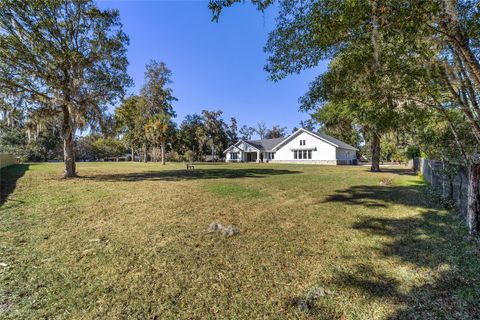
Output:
top-left (224, 128), bottom-right (357, 164)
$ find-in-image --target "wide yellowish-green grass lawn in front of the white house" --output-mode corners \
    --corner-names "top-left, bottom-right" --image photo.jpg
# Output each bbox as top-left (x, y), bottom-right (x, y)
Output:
top-left (0, 163), bottom-right (480, 319)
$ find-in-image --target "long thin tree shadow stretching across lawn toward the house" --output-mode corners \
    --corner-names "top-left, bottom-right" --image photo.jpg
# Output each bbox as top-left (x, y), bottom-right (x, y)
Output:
top-left (79, 168), bottom-right (302, 182)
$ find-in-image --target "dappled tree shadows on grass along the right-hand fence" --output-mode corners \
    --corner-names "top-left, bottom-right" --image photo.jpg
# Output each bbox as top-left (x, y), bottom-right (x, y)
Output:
top-left (327, 185), bottom-right (480, 319)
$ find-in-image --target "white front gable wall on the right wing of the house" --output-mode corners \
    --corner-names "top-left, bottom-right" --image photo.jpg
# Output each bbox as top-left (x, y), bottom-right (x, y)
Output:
top-left (272, 132), bottom-right (336, 162)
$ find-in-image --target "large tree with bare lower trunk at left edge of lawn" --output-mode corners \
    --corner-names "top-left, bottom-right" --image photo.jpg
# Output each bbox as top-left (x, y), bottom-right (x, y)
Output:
top-left (0, 0), bottom-right (131, 177)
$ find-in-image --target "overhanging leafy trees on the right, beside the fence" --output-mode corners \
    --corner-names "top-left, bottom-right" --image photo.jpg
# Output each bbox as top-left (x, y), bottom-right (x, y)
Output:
top-left (209, 0), bottom-right (480, 234)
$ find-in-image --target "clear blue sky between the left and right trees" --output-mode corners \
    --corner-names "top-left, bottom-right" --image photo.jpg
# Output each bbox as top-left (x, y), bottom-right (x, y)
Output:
top-left (98, 0), bottom-right (326, 135)
